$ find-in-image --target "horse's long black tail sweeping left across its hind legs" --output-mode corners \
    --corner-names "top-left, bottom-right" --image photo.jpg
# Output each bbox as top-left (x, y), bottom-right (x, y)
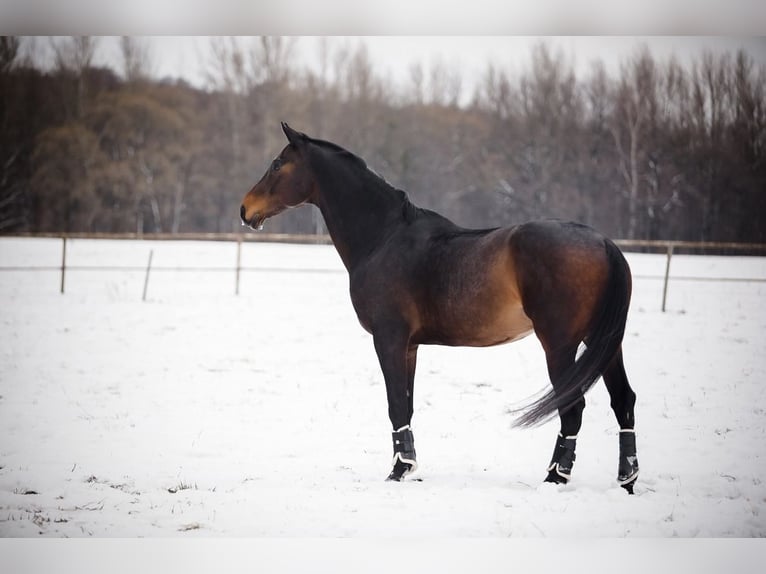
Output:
top-left (514, 239), bottom-right (631, 427)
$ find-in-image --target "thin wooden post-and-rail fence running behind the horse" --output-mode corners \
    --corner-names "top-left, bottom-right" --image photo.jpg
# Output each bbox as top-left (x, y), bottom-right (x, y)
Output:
top-left (0, 233), bottom-right (766, 311)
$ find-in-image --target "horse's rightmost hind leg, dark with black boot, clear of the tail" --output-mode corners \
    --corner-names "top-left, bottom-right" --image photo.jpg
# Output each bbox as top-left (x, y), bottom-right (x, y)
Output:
top-left (604, 349), bottom-right (638, 494)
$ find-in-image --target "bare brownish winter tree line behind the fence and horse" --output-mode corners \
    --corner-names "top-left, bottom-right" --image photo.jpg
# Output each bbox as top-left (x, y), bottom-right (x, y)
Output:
top-left (0, 36), bottom-right (766, 242)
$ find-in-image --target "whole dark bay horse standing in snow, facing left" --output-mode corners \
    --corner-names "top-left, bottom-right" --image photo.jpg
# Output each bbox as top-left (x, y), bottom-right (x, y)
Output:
top-left (240, 123), bottom-right (638, 493)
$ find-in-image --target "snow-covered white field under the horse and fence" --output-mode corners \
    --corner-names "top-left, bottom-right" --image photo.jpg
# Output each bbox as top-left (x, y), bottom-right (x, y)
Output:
top-left (0, 235), bottom-right (766, 537)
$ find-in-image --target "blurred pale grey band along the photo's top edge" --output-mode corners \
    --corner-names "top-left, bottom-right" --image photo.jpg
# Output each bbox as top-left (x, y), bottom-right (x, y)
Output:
top-left (0, 0), bottom-right (766, 36)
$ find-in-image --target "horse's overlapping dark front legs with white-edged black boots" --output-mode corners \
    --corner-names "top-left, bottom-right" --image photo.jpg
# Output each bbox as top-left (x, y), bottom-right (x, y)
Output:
top-left (373, 330), bottom-right (418, 482)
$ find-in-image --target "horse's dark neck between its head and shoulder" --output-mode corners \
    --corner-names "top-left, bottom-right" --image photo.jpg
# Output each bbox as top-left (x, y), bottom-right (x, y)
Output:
top-left (313, 153), bottom-right (406, 271)
